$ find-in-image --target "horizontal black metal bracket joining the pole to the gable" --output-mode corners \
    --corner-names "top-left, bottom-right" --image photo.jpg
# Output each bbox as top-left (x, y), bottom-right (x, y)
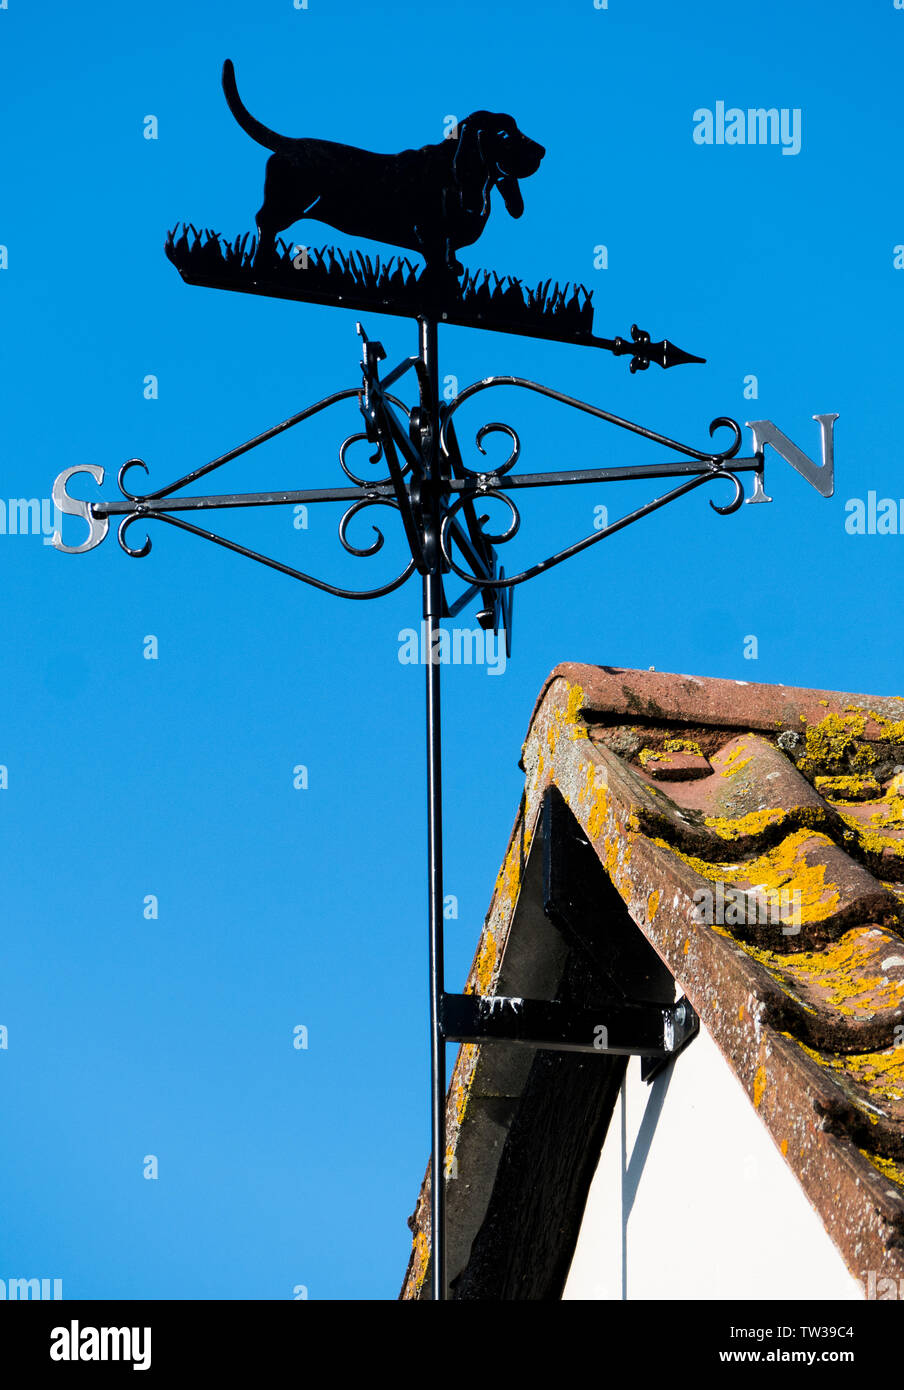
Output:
top-left (439, 994), bottom-right (700, 1070)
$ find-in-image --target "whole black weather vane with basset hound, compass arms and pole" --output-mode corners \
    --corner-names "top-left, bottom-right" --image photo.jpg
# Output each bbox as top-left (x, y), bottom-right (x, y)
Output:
top-left (53, 61), bottom-right (837, 1300)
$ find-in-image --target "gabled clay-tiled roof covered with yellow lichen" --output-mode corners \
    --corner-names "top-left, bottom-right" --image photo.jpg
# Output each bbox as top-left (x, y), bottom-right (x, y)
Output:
top-left (402, 664), bottom-right (904, 1298)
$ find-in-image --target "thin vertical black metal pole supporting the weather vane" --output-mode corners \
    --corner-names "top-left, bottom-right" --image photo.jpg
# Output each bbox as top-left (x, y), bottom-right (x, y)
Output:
top-left (417, 309), bottom-right (446, 1302)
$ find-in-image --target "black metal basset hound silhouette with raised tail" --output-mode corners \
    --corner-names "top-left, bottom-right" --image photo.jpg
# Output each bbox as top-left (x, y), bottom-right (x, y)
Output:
top-left (223, 58), bottom-right (547, 274)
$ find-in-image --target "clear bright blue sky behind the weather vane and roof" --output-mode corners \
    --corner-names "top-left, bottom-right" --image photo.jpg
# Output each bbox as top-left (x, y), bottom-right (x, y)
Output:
top-left (0, 0), bottom-right (904, 1300)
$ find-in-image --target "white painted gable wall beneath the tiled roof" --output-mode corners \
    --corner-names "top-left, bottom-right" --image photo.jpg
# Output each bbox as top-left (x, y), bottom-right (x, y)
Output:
top-left (563, 1027), bottom-right (864, 1300)
